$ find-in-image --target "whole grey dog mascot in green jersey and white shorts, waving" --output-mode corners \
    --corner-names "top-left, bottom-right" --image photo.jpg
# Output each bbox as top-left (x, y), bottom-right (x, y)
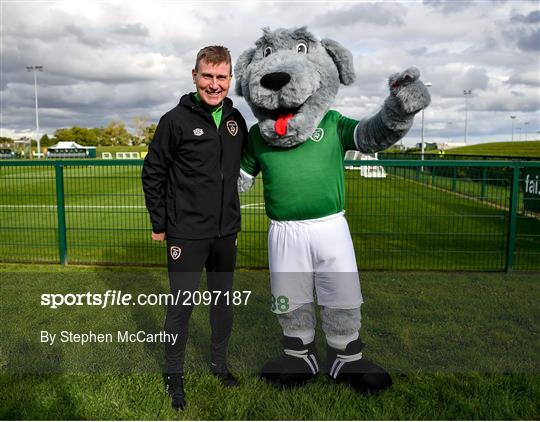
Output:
top-left (235, 27), bottom-right (430, 391)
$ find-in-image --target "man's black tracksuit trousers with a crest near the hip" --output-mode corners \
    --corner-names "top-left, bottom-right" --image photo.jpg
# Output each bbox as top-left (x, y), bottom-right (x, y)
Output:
top-left (165, 234), bottom-right (236, 374)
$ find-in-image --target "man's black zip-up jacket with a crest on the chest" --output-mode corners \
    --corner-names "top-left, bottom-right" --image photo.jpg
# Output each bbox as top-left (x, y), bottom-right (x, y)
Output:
top-left (142, 94), bottom-right (248, 239)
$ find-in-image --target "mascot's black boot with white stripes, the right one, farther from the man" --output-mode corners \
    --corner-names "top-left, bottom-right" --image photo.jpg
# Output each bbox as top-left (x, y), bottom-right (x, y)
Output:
top-left (327, 339), bottom-right (392, 392)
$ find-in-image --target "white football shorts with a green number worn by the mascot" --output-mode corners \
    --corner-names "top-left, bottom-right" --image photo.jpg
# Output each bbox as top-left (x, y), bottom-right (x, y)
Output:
top-left (268, 212), bottom-right (363, 314)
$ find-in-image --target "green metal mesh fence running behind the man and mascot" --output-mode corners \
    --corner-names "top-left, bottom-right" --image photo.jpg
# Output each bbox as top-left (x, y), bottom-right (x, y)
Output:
top-left (0, 160), bottom-right (540, 271)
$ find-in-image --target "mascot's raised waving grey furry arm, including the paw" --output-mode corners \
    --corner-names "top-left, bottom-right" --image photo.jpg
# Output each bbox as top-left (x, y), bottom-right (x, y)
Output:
top-left (354, 67), bottom-right (431, 153)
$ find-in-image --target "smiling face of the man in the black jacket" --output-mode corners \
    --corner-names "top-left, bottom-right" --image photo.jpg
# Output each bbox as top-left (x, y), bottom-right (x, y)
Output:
top-left (192, 60), bottom-right (231, 107)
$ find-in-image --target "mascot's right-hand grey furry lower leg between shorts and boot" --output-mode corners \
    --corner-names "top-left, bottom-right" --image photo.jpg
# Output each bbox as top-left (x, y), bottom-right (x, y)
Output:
top-left (321, 307), bottom-right (361, 350)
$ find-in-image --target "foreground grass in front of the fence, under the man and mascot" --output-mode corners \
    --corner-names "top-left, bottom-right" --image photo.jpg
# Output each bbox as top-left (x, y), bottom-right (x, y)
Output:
top-left (0, 264), bottom-right (540, 420)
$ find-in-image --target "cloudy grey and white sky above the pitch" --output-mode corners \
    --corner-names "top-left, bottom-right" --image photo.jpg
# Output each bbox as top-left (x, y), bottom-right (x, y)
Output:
top-left (0, 0), bottom-right (540, 145)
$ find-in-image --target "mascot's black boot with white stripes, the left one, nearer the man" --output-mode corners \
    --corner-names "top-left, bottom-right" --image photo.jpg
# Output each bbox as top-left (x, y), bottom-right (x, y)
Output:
top-left (260, 336), bottom-right (319, 387)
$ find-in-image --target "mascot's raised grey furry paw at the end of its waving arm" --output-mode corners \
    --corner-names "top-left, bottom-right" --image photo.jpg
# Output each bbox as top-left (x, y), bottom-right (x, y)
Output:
top-left (388, 67), bottom-right (431, 115)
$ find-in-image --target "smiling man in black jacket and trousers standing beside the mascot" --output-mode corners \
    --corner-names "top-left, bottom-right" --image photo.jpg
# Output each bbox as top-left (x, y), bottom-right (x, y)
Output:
top-left (142, 46), bottom-right (247, 409)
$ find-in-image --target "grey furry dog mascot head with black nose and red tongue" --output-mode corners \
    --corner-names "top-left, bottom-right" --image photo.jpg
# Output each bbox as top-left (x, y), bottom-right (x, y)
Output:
top-left (234, 27), bottom-right (355, 148)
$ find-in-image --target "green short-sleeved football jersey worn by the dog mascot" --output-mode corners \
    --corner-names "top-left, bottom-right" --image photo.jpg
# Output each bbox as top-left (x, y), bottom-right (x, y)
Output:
top-left (241, 110), bottom-right (358, 221)
